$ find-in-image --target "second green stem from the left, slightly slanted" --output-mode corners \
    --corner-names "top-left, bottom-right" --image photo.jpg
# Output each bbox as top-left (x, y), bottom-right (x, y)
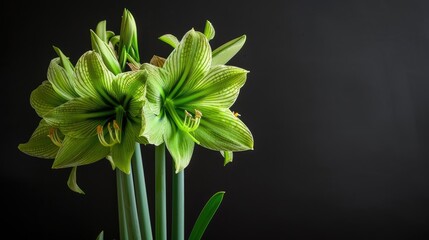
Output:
top-left (132, 143), bottom-right (152, 240)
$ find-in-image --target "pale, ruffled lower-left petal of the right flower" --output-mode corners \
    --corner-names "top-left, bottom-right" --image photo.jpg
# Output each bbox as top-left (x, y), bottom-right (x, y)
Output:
top-left (140, 103), bottom-right (170, 146)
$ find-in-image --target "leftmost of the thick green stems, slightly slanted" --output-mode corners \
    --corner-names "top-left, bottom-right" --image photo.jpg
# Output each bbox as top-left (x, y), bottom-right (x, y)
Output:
top-left (118, 170), bottom-right (141, 240)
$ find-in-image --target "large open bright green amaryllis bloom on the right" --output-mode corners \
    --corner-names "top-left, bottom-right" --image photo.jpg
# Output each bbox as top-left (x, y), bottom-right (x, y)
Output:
top-left (142, 29), bottom-right (253, 172)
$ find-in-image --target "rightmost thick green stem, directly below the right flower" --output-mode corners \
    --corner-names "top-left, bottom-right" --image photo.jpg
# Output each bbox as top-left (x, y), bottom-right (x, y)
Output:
top-left (171, 169), bottom-right (185, 240)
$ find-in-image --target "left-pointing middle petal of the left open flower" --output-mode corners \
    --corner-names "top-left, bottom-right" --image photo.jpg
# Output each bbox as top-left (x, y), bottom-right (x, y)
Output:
top-left (44, 97), bottom-right (110, 138)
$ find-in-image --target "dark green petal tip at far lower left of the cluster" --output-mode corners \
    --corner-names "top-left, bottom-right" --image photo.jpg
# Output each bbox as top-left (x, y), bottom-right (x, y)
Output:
top-left (18, 120), bottom-right (59, 159)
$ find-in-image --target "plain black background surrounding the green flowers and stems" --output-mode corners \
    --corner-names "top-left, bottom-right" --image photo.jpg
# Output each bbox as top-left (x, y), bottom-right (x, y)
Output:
top-left (1, 0), bottom-right (429, 239)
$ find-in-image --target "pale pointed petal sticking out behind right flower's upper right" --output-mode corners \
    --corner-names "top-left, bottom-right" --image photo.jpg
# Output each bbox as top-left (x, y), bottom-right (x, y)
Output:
top-left (212, 35), bottom-right (246, 66)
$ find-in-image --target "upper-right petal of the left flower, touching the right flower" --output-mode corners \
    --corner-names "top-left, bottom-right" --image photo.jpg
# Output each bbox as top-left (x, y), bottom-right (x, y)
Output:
top-left (113, 70), bottom-right (147, 117)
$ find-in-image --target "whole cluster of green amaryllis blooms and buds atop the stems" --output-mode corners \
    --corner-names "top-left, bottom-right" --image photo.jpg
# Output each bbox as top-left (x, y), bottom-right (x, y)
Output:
top-left (19, 10), bottom-right (253, 190)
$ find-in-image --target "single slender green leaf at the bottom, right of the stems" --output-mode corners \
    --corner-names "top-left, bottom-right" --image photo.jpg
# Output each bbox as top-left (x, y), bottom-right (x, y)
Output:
top-left (189, 191), bottom-right (225, 240)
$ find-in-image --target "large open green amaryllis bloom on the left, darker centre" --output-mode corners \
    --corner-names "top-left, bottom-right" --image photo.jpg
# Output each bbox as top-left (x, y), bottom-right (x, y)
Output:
top-left (21, 51), bottom-right (146, 173)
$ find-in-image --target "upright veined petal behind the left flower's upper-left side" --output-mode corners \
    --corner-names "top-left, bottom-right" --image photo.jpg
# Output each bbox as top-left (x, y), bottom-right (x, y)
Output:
top-left (47, 57), bottom-right (79, 100)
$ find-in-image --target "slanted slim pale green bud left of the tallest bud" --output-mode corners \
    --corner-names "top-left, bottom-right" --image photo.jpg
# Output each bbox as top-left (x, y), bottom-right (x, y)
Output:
top-left (91, 30), bottom-right (121, 75)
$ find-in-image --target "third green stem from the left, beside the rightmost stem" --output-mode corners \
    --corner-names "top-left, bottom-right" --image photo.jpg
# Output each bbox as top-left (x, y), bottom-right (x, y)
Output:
top-left (155, 143), bottom-right (167, 240)
